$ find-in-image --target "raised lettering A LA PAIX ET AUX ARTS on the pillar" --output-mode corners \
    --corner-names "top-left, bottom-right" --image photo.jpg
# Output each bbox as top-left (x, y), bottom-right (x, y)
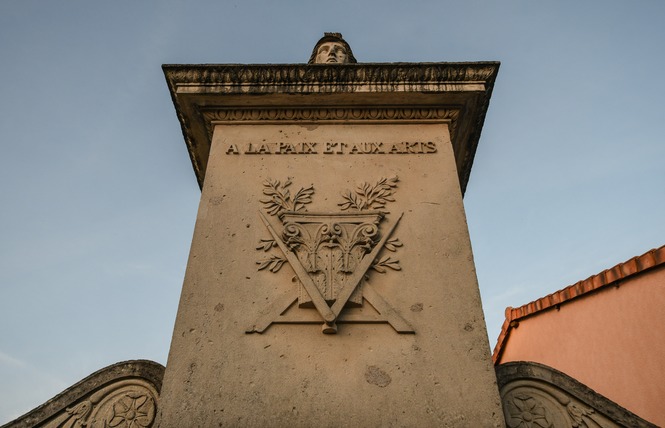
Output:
top-left (225, 141), bottom-right (437, 155)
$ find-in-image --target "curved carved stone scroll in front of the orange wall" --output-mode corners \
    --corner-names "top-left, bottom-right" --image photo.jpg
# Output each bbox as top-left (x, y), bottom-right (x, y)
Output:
top-left (495, 361), bottom-right (656, 428)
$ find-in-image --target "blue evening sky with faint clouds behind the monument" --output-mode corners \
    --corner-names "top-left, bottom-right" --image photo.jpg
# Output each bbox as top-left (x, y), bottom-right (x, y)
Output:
top-left (0, 0), bottom-right (665, 423)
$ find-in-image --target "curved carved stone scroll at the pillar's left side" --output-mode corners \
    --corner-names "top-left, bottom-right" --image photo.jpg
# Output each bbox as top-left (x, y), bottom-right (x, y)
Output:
top-left (0, 360), bottom-right (164, 428)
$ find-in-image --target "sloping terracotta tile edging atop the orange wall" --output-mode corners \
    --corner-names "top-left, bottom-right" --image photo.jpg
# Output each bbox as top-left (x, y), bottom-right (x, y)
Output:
top-left (492, 245), bottom-right (665, 364)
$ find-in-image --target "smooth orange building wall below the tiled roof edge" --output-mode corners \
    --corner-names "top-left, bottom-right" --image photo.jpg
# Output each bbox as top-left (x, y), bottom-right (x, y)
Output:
top-left (497, 265), bottom-right (665, 426)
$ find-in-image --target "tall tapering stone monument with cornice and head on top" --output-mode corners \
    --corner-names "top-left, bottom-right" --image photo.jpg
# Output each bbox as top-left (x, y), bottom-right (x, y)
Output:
top-left (157, 33), bottom-right (504, 427)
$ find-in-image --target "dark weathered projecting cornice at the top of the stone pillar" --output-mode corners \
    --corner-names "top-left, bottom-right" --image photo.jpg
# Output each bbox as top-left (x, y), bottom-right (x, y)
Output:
top-left (162, 62), bottom-right (499, 192)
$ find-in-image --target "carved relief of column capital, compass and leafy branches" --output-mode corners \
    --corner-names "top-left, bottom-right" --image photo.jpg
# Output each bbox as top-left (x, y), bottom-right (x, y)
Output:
top-left (247, 177), bottom-right (413, 334)
